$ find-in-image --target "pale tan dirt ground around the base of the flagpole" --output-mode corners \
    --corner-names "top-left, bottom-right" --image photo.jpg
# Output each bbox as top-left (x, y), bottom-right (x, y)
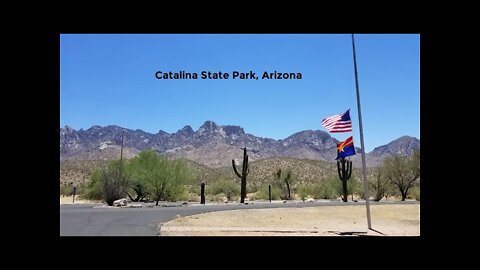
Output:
top-left (159, 204), bottom-right (420, 236)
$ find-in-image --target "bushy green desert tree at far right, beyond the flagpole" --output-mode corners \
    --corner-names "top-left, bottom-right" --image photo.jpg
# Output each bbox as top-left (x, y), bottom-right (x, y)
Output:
top-left (382, 150), bottom-right (420, 201)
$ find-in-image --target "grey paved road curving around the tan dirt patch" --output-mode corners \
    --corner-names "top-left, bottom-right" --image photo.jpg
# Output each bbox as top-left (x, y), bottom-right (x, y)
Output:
top-left (60, 201), bottom-right (417, 236)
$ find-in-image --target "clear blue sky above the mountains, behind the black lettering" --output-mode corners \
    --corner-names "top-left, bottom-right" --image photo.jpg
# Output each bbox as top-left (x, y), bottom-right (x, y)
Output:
top-left (60, 34), bottom-right (420, 152)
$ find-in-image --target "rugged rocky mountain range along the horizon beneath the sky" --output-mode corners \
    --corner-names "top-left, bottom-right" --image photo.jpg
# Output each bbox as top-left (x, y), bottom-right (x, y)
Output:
top-left (60, 121), bottom-right (420, 168)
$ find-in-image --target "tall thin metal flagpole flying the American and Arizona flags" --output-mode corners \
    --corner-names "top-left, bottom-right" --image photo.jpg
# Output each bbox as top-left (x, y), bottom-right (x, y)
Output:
top-left (352, 34), bottom-right (372, 229)
